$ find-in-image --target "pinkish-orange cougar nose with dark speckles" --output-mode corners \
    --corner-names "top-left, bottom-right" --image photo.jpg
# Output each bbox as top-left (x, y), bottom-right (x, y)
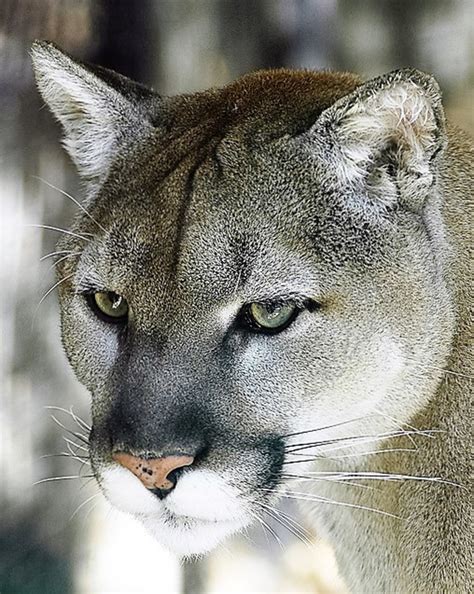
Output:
top-left (112, 452), bottom-right (194, 499)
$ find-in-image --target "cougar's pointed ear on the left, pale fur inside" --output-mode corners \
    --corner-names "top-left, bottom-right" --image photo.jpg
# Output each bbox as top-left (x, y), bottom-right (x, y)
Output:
top-left (31, 41), bottom-right (153, 181)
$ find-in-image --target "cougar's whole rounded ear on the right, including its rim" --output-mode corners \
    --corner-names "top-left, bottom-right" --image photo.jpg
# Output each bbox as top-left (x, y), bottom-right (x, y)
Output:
top-left (310, 69), bottom-right (446, 211)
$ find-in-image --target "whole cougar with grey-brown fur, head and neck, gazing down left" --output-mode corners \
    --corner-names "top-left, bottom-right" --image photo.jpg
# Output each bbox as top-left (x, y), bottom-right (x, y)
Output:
top-left (32, 42), bottom-right (474, 593)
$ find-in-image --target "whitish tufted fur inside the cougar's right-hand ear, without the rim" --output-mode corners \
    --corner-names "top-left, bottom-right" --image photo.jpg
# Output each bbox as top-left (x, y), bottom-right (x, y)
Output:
top-left (326, 80), bottom-right (438, 204)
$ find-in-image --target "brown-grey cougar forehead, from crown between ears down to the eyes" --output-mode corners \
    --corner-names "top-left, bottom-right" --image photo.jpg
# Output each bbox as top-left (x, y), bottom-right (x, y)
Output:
top-left (78, 70), bottom-right (386, 320)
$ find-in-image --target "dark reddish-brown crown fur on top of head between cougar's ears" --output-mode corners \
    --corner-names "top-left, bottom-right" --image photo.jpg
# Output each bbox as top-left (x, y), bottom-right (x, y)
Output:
top-left (153, 68), bottom-right (361, 142)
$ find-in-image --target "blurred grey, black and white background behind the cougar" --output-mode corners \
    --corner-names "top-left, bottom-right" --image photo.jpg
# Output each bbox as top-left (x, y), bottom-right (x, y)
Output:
top-left (0, 0), bottom-right (474, 594)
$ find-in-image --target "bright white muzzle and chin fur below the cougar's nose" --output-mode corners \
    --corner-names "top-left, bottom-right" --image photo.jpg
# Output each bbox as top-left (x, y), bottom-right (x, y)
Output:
top-left (100, 465), bottom-right (250, 556)
